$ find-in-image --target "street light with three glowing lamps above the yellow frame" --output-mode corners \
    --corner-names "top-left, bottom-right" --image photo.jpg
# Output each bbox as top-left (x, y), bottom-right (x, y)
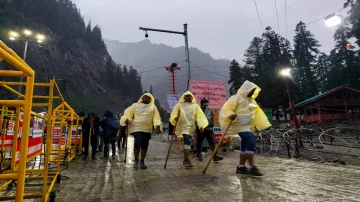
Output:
top-left (9, 29), bottom-right (45, 93)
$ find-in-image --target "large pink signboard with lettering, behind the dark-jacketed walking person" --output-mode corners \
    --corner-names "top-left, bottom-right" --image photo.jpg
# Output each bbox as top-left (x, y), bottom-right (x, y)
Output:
top-left (190, 80), bottom-right (226, 109)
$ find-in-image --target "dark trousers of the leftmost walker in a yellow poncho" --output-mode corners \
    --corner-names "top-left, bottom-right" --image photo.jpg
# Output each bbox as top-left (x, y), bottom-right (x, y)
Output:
top-left (132, 132), bottom-right (151, 161)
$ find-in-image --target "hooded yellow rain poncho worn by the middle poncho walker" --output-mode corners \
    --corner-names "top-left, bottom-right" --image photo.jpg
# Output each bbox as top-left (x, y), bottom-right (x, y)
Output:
top-left (170, 91), bottom-right (209, 136)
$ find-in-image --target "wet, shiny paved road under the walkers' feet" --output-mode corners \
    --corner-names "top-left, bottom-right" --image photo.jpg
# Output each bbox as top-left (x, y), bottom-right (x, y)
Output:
top-left (55, 138), bottom-right (360, 202)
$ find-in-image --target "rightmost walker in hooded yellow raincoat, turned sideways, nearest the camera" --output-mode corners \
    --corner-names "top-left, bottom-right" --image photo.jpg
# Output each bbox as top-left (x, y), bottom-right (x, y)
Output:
top-left (219, 81), bottom-right (271, 176)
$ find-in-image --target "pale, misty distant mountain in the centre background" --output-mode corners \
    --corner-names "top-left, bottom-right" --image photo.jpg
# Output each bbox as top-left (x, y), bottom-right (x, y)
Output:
top-left (105, 39), bottom-right (230, 106)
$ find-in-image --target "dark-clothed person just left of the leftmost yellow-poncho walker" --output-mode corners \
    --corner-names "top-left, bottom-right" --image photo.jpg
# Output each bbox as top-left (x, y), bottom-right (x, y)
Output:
top-left (100, 110), bottom-right (117, 158)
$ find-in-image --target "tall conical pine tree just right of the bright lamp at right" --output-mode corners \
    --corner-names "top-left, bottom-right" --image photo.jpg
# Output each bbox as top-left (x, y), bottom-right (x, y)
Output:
top-left (294, 22), bottom-right (320, 100)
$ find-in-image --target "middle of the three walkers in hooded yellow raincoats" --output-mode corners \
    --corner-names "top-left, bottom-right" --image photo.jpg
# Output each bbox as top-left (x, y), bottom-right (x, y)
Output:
top-left (170, 91), bottom-right (209, 168)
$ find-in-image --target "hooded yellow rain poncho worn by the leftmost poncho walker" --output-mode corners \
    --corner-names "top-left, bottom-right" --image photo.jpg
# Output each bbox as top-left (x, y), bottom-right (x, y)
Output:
top-left (120, 93), bottom-right (162, 134)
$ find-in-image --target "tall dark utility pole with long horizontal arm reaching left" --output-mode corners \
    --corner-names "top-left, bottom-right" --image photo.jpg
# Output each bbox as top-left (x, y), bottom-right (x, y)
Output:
top-left (139, 24), bottom-right (191, 90)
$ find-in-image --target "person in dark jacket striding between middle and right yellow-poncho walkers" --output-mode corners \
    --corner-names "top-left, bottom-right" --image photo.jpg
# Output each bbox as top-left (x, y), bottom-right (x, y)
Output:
top-left (196, 98), bottom-right (224, 161)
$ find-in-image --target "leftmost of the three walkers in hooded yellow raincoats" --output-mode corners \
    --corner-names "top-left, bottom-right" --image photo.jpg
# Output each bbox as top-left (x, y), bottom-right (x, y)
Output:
top-left (120, 93), bottom-right (162, 169)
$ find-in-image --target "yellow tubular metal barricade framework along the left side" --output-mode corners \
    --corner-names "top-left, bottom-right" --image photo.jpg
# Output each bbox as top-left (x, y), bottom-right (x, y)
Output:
top-left (0, 41), bottom-right (82, 202)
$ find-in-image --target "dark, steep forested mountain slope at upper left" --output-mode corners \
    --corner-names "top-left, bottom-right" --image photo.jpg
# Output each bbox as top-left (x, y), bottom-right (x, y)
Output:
top-left (0, 0), bottom-right (142, 113)
